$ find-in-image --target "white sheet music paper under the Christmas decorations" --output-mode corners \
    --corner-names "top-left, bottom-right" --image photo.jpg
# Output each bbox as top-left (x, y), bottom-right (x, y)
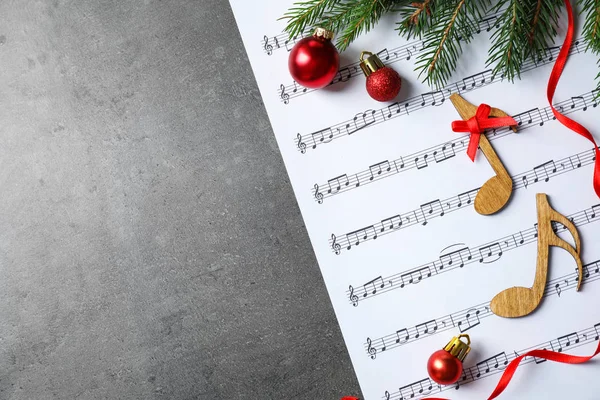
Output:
top-left (230, 0), bottom-right (600, 400)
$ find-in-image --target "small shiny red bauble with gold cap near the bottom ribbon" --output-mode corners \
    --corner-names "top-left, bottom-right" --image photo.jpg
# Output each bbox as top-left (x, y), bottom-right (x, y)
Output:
top-left (427, 335), bottom-right (471, 385)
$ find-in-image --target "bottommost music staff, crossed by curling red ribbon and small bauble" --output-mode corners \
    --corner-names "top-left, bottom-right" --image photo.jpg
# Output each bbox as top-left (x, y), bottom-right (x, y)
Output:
top-left (382, 323), bottom-right (600, 400)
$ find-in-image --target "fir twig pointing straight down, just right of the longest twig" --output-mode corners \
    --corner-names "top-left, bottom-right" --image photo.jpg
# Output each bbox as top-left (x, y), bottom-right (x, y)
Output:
top-left (487, 0), bottom-right (530, 82)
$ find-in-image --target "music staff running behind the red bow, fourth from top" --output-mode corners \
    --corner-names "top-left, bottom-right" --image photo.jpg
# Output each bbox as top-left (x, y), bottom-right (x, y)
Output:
top-left (318, 86), bottom-right (598, 203)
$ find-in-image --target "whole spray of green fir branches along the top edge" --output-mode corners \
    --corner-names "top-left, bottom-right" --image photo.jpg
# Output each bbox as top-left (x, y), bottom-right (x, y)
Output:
top-left (281, 0), bottom-right (600, 88)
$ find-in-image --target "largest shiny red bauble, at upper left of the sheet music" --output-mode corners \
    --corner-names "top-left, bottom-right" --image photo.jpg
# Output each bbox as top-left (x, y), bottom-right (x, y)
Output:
top-left (288, 28), bottom-right (340, 89)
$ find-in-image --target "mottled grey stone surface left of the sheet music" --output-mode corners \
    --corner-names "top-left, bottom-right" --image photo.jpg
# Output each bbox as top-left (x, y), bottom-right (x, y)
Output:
top-left (0, 0), bottom-right (359, 400)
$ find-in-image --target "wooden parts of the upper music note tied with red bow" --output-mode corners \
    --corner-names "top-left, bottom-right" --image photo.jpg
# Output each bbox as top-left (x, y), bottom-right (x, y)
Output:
top-left (450, 93), bottom-right (517, 215)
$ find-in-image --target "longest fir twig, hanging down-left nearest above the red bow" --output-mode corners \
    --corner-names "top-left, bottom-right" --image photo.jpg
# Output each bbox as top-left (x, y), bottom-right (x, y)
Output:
top-left (416, 0), bottom-right (489, 87)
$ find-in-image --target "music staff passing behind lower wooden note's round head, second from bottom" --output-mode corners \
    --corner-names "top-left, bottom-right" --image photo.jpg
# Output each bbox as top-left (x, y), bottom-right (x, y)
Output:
top-left (365, 260), bottom-right (600, 356)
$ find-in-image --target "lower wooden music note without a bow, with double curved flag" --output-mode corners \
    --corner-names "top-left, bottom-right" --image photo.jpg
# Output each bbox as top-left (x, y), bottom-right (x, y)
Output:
top-left (490, 193), bottom-right (583, 318)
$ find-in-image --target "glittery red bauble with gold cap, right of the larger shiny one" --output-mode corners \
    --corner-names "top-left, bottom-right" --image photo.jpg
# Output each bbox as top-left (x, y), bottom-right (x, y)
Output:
top-left (360, 51), bottom-right (402, 101)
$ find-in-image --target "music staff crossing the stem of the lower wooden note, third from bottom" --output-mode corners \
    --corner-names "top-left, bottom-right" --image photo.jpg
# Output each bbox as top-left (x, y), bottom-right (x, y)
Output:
top-left (346, 205), bottom-right (600, 307)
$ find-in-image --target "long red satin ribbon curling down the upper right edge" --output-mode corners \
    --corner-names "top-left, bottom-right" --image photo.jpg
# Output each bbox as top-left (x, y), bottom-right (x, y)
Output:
top-left (547, 0), bottom-right (600, 197)
